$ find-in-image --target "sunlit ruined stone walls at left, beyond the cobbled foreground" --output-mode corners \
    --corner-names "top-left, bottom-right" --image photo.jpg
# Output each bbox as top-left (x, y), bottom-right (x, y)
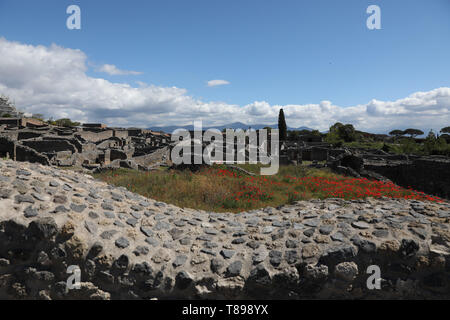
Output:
top-left (0, 118), bottom-right (170, 171)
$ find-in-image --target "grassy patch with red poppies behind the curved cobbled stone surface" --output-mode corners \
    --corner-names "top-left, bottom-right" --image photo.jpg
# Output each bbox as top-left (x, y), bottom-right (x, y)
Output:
top-left (96, 166), bottom-right (442, 212)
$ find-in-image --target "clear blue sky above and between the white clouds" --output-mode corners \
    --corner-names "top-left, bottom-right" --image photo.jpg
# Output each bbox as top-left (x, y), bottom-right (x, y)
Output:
top-left (0, 0), bottom-right (450, 131)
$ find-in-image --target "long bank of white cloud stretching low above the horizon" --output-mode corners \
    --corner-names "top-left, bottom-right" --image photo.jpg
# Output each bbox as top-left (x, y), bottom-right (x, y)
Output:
top-left (0, 38), bottom-right (450, 132)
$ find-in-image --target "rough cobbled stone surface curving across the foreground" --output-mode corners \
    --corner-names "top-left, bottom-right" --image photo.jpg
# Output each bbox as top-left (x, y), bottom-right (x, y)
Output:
top-left (0, 161), bottom-right (450, 299)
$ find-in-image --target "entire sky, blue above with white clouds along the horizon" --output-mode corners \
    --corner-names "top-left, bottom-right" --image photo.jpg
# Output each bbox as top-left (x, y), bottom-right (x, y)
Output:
top-left (0, 0), bottom-right (450, 132)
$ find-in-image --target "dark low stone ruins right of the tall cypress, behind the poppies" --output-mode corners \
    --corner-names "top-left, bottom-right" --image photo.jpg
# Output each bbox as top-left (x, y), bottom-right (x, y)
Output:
top-left (280, 141), bottom-right (450, 199)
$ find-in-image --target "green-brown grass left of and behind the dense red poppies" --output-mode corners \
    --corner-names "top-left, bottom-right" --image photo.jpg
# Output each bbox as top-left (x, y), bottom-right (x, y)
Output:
top-left (94, 164), bottom-right (339, 212)
